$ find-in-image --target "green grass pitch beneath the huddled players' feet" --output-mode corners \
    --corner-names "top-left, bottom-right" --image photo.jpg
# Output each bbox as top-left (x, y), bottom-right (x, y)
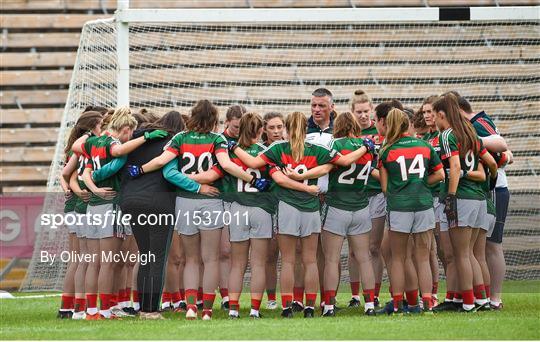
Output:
top-left (0, 281), bottom-right (540, 340)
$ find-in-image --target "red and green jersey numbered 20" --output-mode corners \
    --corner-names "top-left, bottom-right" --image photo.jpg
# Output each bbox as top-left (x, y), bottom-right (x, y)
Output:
top-left (164, 131), bottom-right (227, 199)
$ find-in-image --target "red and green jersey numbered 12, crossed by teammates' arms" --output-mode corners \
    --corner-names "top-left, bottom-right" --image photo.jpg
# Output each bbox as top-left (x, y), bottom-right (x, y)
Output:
top-left (223, 144), bottom-right (276, 214)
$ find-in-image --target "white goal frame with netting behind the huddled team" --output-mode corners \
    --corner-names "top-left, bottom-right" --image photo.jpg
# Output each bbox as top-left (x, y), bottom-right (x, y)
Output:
top-left (21, 0), bottom-right (540, 291)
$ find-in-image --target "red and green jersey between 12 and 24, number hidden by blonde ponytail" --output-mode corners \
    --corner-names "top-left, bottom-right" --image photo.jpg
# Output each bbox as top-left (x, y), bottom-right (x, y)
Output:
top-left (260, 141), bottom-right (339, 212)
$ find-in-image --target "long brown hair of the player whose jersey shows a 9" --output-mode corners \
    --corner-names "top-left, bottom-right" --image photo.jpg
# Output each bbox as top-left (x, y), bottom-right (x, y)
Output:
top-left (433, 93), bottom-right (479, 158)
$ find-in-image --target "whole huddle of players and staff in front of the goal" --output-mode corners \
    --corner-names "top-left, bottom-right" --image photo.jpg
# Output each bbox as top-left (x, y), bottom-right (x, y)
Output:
top-left (59, 88), bottom-right (512, 320)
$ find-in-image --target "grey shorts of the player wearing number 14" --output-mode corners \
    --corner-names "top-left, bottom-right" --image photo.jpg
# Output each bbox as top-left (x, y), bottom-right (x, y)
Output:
top-left (388, 209), bottom-right (435, 234)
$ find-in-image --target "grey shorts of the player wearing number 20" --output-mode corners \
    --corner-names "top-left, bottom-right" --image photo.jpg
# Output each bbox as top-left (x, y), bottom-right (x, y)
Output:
top-left (174, 197), bottom-right (224, 235)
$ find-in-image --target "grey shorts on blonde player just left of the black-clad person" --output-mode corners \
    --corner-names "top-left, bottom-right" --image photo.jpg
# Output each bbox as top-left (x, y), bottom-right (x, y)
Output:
top-left (86, 203), bottom-right (125, 239)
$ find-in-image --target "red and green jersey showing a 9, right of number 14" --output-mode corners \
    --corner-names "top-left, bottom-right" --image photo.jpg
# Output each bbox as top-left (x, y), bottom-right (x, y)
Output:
top-left (440, 128), bottom-right (487, 200)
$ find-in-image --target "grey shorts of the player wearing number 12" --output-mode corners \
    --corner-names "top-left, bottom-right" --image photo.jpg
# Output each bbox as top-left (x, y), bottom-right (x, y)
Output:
top-left (229, 202), bottom-right (273, 242)
